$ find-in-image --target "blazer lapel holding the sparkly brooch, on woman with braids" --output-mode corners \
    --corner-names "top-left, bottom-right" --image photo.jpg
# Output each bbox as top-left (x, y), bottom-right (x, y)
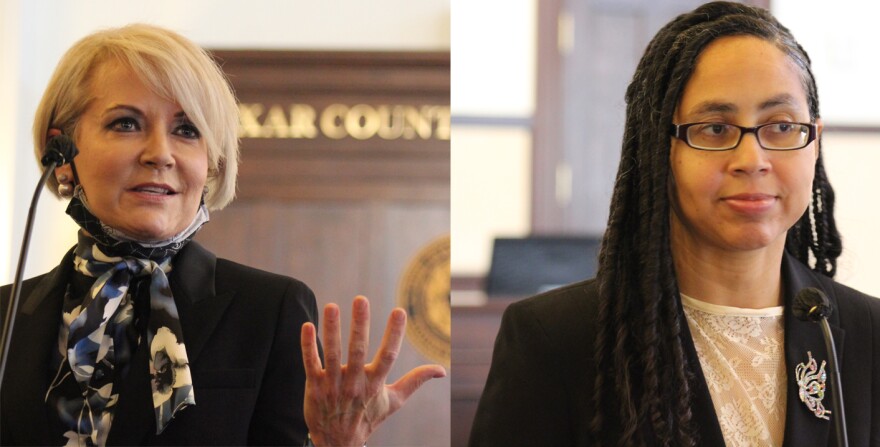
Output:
top-left (782, 253), bottom-right (845, 446)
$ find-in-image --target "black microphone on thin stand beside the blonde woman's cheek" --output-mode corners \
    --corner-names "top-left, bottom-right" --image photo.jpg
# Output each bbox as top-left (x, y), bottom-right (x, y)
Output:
top-left (0, 135), bottom-right (79, 387)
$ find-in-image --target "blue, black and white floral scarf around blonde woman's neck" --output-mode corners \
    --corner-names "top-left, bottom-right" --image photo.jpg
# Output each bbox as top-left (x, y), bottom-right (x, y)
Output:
top-left (46, 187), bottom-right (208, 446)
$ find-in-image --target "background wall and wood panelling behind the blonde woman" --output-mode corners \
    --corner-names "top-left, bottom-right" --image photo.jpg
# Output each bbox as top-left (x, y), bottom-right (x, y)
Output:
top-left (0, 0), bottom-right (450, 447)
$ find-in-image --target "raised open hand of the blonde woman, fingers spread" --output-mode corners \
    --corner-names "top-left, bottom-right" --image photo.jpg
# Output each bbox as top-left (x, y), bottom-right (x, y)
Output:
top-left (300, 296), bottom-right (446, 447)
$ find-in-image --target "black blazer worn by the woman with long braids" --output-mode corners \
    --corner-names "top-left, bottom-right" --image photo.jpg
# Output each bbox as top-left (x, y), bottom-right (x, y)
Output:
top-left (470, 255), bottom-right (880, 447)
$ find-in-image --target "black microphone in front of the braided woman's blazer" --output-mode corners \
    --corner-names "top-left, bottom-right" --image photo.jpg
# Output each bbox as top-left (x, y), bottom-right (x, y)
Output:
top-left (791, 287), bottom-right (849, 447)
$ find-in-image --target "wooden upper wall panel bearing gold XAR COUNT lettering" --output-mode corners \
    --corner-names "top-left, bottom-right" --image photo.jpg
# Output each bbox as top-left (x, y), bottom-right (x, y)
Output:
top-left (215, 51), bottom-right (450, 203)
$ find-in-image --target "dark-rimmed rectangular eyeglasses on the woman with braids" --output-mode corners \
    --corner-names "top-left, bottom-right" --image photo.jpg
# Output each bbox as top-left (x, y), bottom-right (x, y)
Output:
top-left (670, 123), bottom-right (817, 151)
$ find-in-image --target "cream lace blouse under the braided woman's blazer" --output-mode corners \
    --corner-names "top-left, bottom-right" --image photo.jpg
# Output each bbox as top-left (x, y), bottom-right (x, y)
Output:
top-left (681, 294), bottom-right (786, 447)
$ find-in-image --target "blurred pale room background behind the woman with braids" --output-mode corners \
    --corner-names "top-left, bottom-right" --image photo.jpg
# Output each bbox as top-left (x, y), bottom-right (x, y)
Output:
top-left (451, 0), bottom-right (880, 445)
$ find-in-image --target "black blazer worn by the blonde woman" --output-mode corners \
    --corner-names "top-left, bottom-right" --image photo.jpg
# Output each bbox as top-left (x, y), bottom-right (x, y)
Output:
top-left (0, 242), bottom-right (318, 445)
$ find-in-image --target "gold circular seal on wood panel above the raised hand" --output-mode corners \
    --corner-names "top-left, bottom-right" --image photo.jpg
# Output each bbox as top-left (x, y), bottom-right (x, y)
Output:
top-left (397, 235), bottom-right (452, 368)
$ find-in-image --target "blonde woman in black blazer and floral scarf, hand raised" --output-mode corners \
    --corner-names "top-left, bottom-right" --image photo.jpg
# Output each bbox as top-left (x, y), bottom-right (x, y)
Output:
top-left (0, 25), bottom-right (445, 446)
